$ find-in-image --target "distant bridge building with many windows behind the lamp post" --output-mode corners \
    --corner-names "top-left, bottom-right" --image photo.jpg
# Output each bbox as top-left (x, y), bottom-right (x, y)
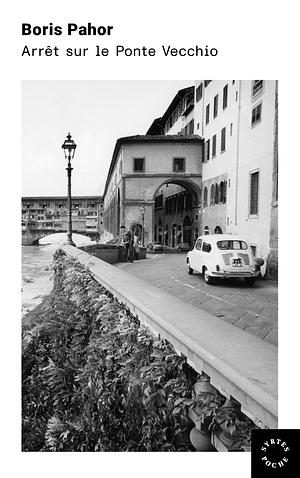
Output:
top-left (22, 196), bottom-right (103, 242)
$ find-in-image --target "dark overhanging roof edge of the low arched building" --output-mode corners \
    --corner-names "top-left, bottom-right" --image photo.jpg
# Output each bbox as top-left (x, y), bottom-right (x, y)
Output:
top-left (103, 134), bottom-right (203, 197)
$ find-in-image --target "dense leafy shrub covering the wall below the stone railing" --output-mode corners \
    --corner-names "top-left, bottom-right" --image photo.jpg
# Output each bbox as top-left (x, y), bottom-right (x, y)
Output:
top-left (22, 250), bottom-right (194, 451)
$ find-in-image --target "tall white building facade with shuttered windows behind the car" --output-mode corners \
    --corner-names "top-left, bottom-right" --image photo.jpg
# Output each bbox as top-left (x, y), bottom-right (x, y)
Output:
top-left (194, 80), bottom-right (278, 274)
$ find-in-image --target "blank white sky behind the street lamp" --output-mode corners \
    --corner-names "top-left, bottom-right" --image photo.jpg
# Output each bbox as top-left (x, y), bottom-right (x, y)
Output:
top-left (22, 80), bottom-right (194, 196)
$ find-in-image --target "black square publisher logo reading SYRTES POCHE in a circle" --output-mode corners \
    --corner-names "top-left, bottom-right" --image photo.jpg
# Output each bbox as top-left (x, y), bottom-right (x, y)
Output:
top-left (251, 430), bottom-right (300, 478)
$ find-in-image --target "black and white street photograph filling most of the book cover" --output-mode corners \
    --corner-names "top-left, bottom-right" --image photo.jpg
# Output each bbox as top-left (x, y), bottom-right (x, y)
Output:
top-left (21, 81), bottom-right (280, 452)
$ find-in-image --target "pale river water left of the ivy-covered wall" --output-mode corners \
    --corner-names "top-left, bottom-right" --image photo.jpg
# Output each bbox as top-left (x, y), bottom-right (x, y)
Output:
top-left (22, 233), bottom-right (93, 316)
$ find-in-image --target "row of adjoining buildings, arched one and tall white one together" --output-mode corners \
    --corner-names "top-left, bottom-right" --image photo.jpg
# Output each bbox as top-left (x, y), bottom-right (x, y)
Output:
top-left (104, 80), bottom-right (278, 276)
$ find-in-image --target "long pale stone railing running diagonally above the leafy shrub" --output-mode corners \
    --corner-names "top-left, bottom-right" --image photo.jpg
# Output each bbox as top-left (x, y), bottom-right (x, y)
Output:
top-left (63, 246), bottom-right (278, 451)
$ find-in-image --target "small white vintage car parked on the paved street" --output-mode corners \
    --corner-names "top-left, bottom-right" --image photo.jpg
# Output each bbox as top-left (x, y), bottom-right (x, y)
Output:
top-left (186, 234), bottom-right (264, 285)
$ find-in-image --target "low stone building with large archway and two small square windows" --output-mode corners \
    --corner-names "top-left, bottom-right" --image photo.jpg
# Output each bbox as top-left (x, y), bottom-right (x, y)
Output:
top-left (103, 135), bottom-right (203, 245)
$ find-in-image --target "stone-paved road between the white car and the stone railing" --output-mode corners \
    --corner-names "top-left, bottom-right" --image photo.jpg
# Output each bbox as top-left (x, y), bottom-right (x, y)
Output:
top-left (116, 253), bottom-right (278, 345)
